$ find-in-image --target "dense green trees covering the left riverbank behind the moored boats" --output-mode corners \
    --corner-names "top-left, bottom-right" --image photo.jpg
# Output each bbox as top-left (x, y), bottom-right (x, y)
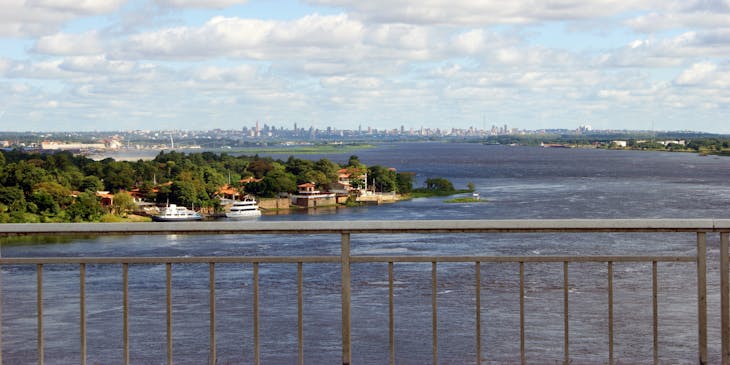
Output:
top-left (0, 150), bottom-right (414, 223)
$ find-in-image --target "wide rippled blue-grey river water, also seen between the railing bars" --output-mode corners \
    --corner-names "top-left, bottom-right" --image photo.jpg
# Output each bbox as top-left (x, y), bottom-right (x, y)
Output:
top-left (1, 143), bottom-right (730, 364)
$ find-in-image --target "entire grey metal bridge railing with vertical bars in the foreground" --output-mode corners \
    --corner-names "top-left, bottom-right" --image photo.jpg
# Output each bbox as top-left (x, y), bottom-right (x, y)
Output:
top-left (0, 219), bottom-right (730, 364)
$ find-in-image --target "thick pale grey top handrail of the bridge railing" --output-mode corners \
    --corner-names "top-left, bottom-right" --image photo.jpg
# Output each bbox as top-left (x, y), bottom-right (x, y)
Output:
top-left (0, 218), bottom-right (730, 236)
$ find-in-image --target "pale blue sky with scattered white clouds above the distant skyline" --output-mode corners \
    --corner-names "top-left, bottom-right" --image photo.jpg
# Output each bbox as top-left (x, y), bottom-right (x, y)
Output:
top-left (0, 0), bottom-right (730, 133)
